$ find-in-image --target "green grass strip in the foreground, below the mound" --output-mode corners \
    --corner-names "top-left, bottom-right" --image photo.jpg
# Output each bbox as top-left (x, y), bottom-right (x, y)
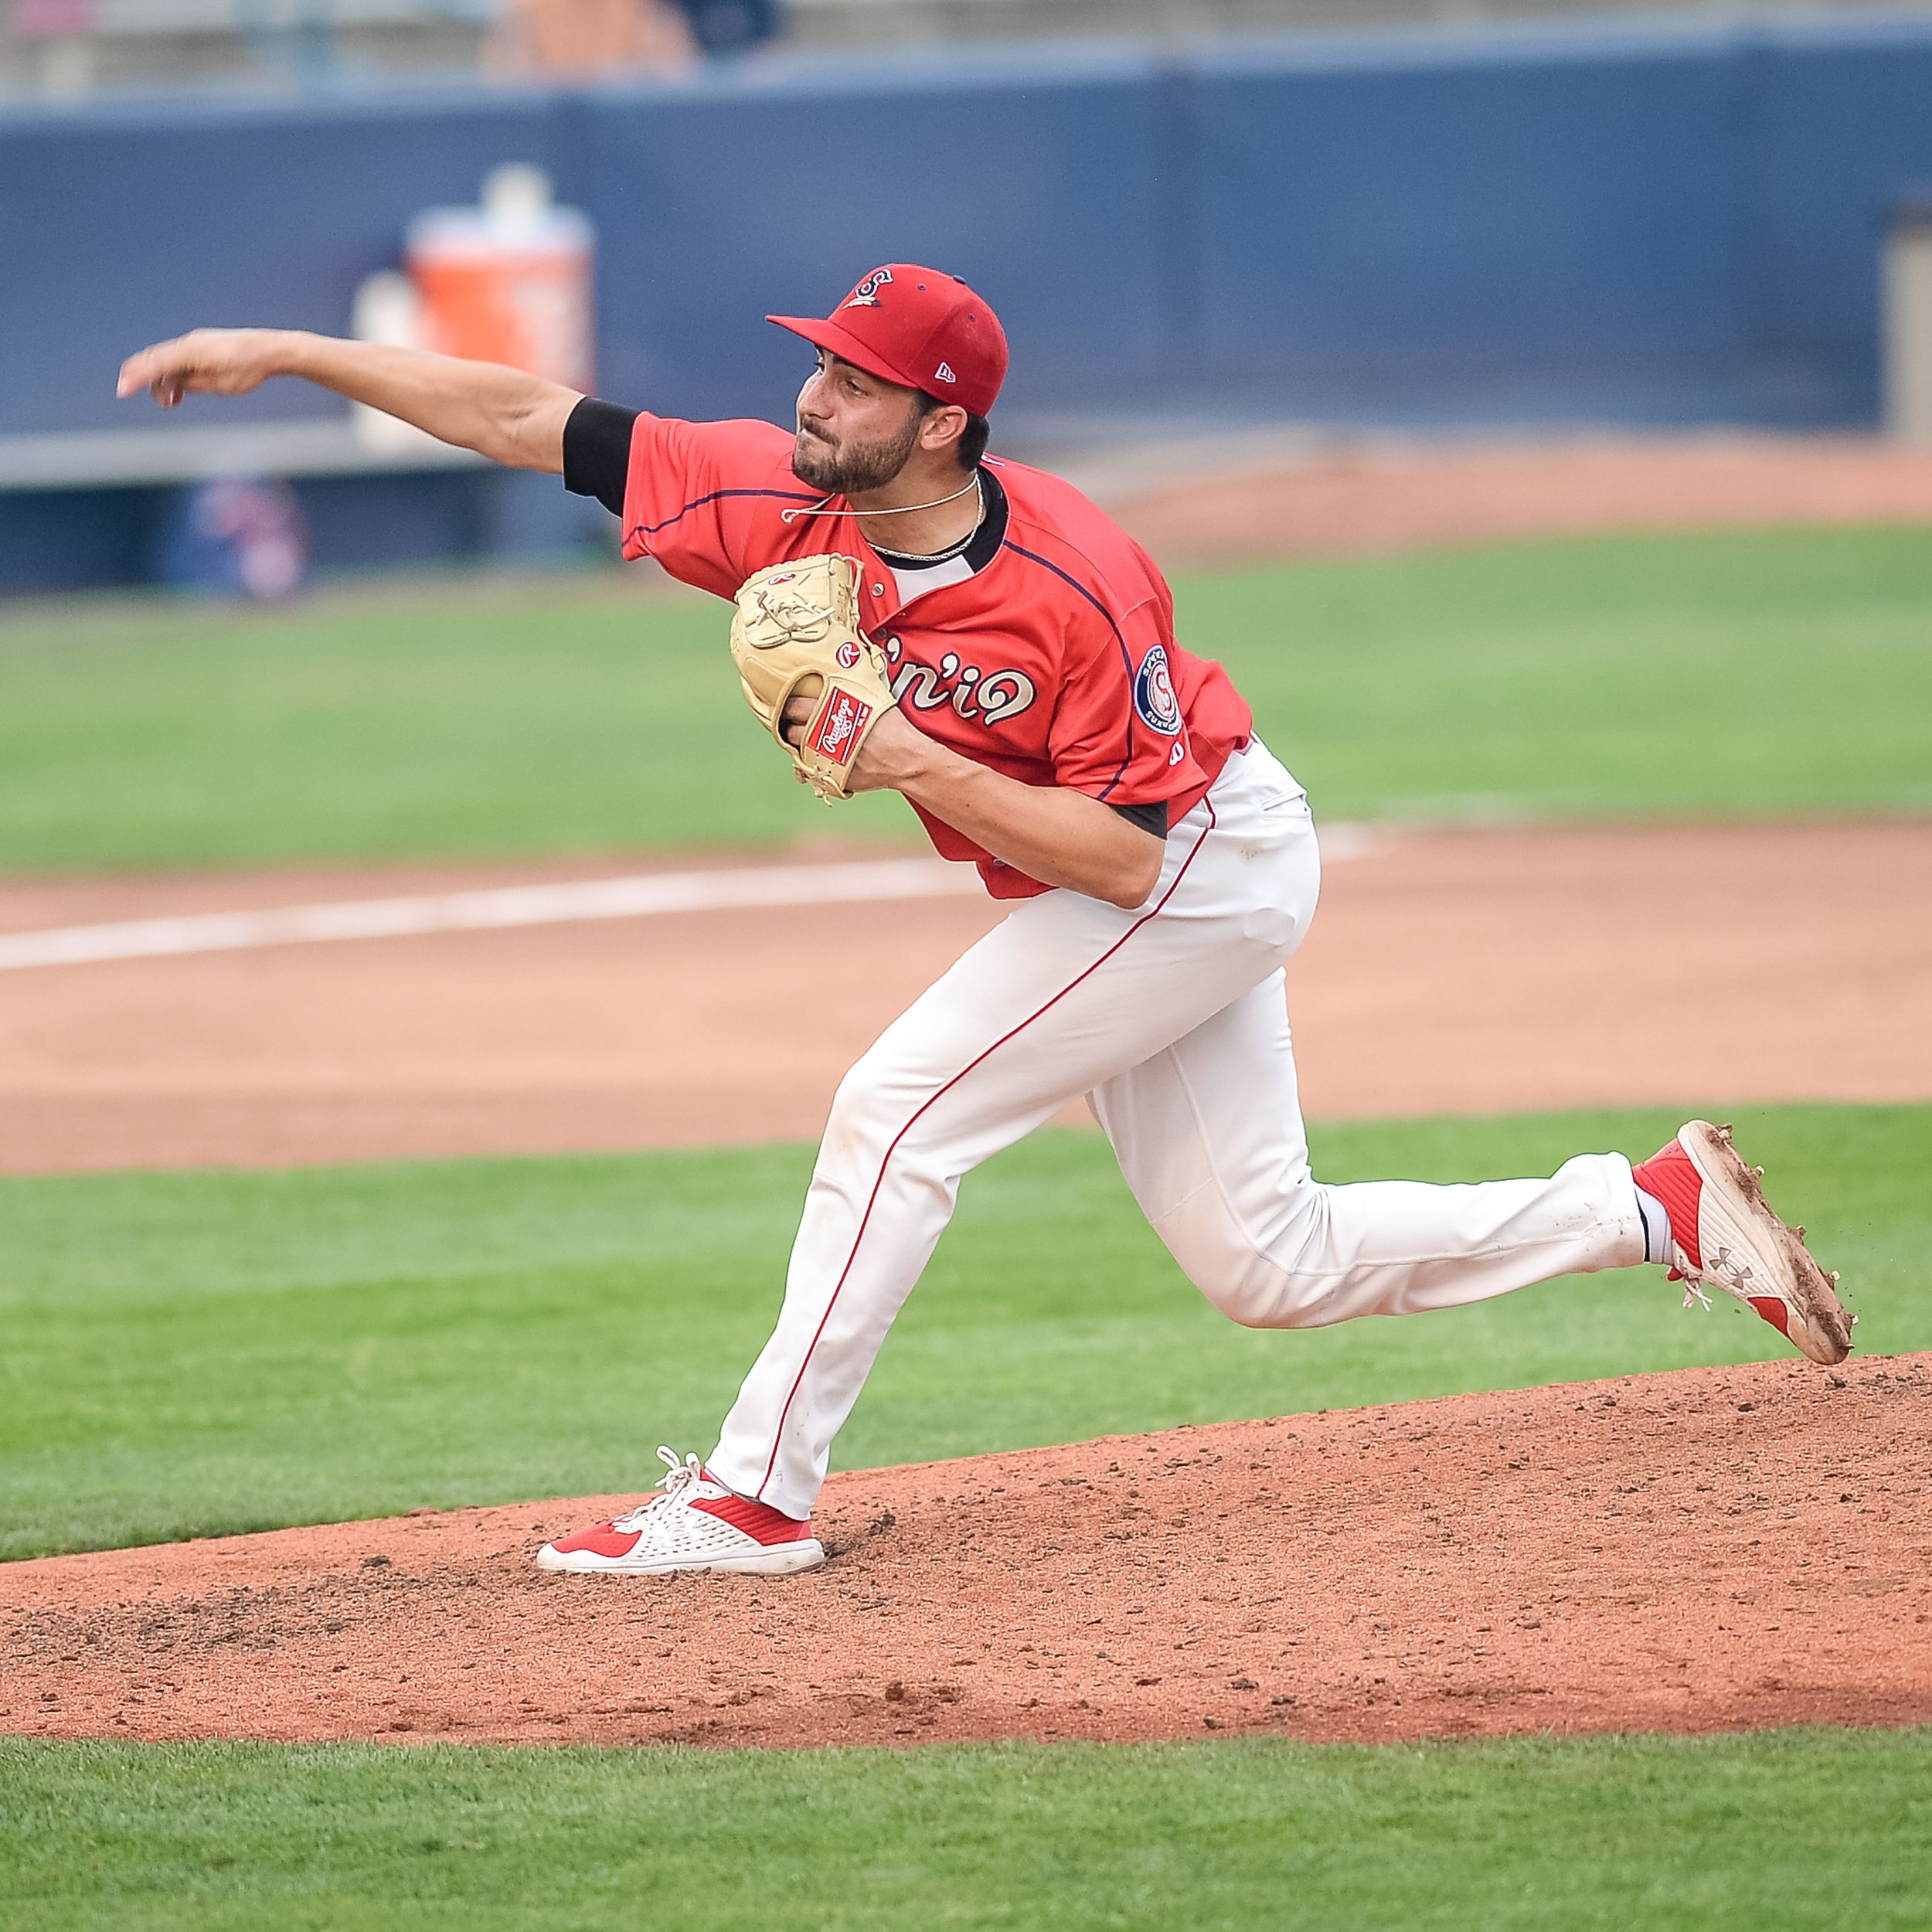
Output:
top-left (0, 1731), bottom-right (1932, 1932)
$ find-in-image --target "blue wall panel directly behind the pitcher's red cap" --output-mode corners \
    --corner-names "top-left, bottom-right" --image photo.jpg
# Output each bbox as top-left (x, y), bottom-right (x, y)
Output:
top-left (590, 56), bottom-right (1165, 427)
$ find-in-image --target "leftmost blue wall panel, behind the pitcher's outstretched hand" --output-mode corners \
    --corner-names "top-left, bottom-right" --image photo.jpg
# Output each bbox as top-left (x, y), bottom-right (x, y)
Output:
top-left (0, 89), bottom-right (580, 435)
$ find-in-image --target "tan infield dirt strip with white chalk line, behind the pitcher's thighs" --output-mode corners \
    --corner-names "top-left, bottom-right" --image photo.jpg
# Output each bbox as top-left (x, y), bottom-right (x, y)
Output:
top-left (0, 821), bottom-right (1932, 1173)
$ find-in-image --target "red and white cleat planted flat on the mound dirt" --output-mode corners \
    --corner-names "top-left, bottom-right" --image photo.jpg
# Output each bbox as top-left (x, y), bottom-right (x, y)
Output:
top-left (537, 1449), bottom-right (825, 1577)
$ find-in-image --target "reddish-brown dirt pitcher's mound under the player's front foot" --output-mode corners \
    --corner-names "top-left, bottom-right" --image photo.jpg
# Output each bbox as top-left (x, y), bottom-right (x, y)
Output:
top-left (0, 1355), bottom-right (1932, 1745)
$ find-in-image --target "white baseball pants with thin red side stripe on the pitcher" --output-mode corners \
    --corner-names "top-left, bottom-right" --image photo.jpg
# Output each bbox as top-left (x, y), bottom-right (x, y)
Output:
top-left (709, 744), bottom-right (1645, 1517)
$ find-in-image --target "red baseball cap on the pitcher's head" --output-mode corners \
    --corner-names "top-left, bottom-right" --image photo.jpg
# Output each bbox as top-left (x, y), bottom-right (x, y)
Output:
top-left (765, 261), bottom-right (1007, 416)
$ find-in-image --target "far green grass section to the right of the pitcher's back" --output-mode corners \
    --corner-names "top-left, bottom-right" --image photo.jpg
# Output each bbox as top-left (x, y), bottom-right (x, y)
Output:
top-left (1179, 529), bottom-right (1932, 819)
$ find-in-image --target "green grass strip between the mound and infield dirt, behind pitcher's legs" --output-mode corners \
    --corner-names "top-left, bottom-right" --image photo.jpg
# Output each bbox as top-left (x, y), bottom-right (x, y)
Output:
top-left (0, 1107), bottom-right (1932, 1557)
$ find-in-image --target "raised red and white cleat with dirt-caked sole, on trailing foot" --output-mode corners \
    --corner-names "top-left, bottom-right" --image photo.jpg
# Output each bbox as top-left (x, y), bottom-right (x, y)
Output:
top-left (1633, 1121), bottom-right (1851, 1364)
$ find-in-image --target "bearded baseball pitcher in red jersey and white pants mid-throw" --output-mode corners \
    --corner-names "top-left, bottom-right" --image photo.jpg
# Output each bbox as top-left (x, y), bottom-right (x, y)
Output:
top-left (120, 261), bottom-right (1851, 1575)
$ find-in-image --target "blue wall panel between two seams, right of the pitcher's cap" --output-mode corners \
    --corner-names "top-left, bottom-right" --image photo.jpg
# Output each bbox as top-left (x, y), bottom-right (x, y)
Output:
top-left (1198, 37), bottom-right (1743, 362)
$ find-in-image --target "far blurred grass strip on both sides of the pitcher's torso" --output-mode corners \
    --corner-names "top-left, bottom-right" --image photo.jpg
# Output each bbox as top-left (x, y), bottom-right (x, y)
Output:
top-left (0, 529), bottom-right (1932, 872)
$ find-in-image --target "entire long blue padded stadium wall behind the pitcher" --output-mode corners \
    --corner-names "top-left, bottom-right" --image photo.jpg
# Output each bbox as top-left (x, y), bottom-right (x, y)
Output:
top-left (11, 19), bottom-right (1932, 590)
